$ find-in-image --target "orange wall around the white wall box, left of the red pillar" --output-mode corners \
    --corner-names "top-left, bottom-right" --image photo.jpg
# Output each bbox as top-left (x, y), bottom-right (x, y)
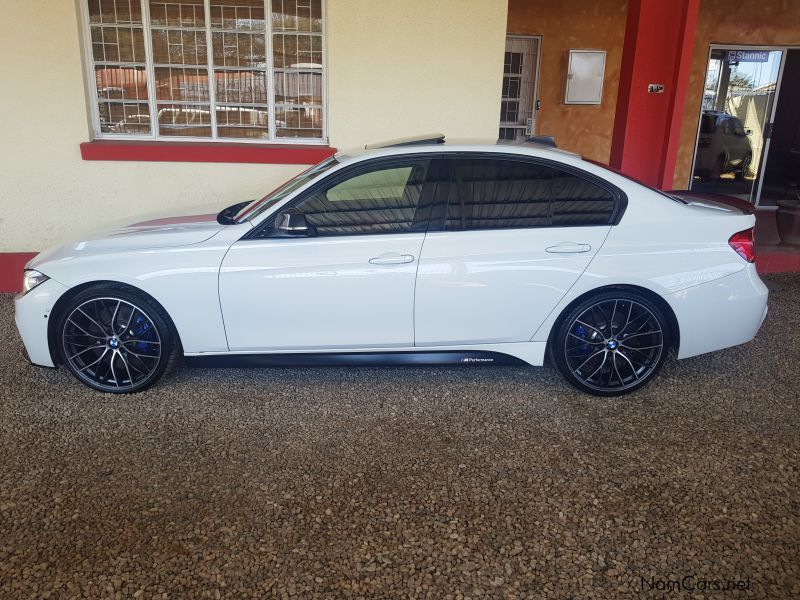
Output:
top-left (508, 0), bottom-right (628, 162)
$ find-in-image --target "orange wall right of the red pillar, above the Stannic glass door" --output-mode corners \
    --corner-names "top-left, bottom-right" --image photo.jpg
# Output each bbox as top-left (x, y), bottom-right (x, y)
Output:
top-left (673, 0), bottom-right (800, 189)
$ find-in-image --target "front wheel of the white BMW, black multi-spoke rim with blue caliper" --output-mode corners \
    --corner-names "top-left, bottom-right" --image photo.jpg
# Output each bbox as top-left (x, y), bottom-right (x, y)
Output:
top-left (54, 285), bottom-right (177, 394)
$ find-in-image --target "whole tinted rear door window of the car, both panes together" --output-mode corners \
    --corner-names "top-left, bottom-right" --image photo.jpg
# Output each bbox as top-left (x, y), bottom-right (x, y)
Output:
top-left (445, 158), bottom-right (616, 230)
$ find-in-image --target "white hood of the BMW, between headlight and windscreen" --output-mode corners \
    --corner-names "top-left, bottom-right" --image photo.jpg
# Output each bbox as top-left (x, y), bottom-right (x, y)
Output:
top-left (28, 206), bottom-right (225, 268)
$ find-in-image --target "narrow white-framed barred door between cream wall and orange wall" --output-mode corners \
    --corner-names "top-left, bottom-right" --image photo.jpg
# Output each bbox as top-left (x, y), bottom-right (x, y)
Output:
top-left (498, 35), bottom-right (541, 140)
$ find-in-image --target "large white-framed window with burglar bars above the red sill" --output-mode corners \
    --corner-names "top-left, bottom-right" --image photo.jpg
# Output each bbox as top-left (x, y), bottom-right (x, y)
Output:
top-left (85, 0), bottom-right (325, 141)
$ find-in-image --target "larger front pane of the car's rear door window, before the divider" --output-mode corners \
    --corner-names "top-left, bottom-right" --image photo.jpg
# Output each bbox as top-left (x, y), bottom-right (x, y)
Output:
top-left (445, 158), bottom-right (552, 229)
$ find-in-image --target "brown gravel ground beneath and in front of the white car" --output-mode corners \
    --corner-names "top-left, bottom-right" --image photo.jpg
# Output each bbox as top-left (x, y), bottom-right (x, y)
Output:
top-left (0, 275), bottom-right (800, 598)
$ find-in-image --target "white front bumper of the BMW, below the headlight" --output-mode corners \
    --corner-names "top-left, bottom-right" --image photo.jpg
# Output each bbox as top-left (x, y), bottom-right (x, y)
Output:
top-left (14, 279), bottom-right (68, 367)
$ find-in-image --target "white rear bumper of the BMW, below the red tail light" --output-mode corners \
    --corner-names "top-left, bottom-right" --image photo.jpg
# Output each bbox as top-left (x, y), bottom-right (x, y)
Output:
top-left (667, 264), bottom-right (769, 358)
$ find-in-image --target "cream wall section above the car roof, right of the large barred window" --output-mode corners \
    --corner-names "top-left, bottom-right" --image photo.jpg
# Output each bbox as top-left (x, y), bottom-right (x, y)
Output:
top-left (327, 0), bottom-right (508, 148)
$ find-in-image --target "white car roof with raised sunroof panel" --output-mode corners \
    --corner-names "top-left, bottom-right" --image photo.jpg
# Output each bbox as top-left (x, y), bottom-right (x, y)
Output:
top-left (336, 133), bottom-right (581, 162)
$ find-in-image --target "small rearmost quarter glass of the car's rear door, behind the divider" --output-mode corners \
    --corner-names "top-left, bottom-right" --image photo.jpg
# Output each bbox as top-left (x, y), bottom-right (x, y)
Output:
top-left (551, 169), bottom-right (615, 227)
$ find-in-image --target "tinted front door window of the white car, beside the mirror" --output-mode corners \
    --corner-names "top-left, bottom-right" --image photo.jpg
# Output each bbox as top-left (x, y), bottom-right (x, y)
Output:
top-left (297, 160), bottom-right (427, 236)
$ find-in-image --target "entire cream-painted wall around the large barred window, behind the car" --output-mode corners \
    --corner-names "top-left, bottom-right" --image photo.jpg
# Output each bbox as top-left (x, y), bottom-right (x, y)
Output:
top-left (0, 0), bottom-right (507, 252)
